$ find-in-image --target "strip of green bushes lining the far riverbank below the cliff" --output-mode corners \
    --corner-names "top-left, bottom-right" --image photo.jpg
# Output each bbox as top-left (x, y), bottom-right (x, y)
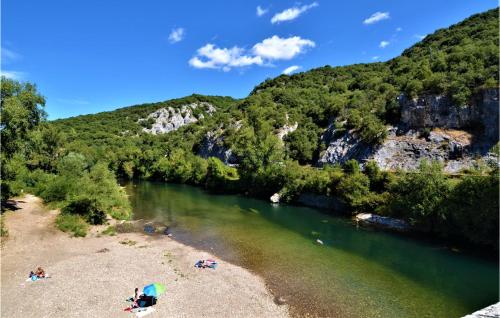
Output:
top-left (144, 154), bottom-right (499, 252)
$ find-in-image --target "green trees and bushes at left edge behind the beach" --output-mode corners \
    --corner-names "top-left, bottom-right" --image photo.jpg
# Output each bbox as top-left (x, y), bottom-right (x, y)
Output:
top-left (1, 77), bottom-right (131, 235)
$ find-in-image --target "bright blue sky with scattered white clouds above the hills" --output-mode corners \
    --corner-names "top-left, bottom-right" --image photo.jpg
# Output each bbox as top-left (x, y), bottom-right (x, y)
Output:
top-left (1, 0), bottom-right (497, 119)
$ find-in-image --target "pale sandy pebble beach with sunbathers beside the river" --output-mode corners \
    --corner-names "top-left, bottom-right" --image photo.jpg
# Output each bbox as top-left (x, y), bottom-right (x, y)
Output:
top-left (0, 195), bottom-right (288, 317)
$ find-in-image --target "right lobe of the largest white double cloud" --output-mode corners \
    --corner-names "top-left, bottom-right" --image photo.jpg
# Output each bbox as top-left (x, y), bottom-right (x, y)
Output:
top-left (253, 35), bottom-right (316, 60)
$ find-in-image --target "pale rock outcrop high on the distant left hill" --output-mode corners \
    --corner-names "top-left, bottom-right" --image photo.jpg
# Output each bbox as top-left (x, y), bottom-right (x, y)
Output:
top-left (138, 102), bottom-right (216, 135)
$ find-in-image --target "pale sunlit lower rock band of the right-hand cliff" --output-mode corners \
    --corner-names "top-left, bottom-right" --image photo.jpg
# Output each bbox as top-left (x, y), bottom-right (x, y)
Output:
top-left (317, 127), bottom-right (498, 173)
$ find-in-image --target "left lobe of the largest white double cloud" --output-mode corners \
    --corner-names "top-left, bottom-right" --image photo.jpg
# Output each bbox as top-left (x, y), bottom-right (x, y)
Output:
top-left (189, 43), bottom-right (263, 72)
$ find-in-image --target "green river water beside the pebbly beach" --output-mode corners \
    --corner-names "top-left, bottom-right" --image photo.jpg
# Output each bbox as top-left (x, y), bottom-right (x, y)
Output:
top-left (126, 182), bottom-right (499, 317)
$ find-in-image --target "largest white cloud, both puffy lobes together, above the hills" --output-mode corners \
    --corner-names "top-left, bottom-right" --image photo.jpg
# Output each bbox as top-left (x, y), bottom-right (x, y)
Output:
top-left (189, 35), bottom-right (316, 72)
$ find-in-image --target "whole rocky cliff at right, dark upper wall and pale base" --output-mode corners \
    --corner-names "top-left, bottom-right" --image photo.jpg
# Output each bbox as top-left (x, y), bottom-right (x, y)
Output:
top-left (317, 89), bottom-right (499, 173)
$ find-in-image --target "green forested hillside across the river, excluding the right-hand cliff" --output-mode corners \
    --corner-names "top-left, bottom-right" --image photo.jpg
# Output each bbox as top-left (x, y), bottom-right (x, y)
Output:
top-left (2, 9), bottom-right (499, 249)
